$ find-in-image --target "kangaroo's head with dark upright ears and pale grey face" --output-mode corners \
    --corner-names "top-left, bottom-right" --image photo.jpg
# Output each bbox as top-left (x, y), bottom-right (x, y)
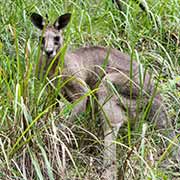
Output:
top-left (31, 13), bottom-right (71, 58)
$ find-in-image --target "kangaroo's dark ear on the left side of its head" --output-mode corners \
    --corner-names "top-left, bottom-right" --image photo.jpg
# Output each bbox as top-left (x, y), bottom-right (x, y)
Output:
top-left (30, 13), bottom-right (45, 30)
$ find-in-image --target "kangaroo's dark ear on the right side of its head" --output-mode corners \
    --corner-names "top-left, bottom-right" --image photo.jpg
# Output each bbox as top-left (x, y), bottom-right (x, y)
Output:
top-left (54, 13), bottom-right (71, 30)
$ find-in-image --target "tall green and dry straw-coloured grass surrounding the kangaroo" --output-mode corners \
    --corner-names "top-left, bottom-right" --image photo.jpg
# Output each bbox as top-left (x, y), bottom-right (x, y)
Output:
top-left (0, 0), bottom-right (180, 180)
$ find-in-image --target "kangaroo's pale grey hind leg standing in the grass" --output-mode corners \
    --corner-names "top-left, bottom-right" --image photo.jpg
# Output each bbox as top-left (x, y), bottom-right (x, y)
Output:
top-left (98, 74), bottom-right (126, 180)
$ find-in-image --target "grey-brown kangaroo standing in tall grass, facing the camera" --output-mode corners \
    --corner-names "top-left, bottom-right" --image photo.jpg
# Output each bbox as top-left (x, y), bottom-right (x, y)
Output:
top-left (30, 13), bottom-right (180, 180)
